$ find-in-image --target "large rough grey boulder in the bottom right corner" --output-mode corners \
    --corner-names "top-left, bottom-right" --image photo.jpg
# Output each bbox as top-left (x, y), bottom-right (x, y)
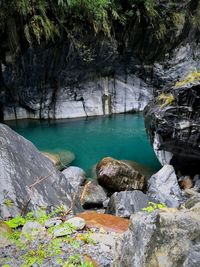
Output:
top-left (113, 206), bottom-right (200, 267)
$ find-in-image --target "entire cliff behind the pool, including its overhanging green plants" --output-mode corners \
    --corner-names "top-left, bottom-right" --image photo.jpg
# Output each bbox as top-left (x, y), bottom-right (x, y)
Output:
top-left (0, 0), bottom-right (200, 120)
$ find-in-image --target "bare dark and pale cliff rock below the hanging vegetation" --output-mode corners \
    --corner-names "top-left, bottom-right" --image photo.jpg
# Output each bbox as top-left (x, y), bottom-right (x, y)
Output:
top-left (0, 0), bottom-right (200, 120)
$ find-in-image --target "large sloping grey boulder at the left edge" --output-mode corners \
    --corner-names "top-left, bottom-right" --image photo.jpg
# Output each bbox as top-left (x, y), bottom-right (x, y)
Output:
top-left (0, 124), bottom-right (72, 218)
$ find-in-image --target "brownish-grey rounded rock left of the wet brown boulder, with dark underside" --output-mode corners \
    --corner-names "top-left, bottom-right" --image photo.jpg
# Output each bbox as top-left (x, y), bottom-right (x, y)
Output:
top-left (80, 181), bottom-right (107, 209)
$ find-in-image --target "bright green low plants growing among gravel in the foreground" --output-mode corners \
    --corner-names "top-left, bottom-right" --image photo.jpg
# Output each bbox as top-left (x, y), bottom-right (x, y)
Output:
top-left (1, 206), bottom-right (95, 267)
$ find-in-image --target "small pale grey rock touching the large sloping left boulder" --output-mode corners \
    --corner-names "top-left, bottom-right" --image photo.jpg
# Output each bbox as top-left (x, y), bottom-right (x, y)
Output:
top-left (62, 166), bottom-right (86, 191)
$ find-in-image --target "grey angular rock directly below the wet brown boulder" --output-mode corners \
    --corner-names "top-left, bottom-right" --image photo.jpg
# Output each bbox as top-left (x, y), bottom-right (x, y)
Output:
top-left (106, 190), bottom-right (149, 218)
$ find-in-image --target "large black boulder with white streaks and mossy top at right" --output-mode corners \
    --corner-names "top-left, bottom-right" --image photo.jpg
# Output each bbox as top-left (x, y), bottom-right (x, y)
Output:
top-left (144, 78), bottom-right (200, 177)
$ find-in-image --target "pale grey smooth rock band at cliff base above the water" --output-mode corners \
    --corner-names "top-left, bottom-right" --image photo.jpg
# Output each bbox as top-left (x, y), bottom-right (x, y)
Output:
top-left (3, 74), bottom-right (153, 120)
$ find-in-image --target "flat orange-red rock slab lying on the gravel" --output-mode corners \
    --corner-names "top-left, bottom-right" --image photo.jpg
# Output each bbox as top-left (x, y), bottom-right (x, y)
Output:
top-left (76, 212), bottom-right (129, 233)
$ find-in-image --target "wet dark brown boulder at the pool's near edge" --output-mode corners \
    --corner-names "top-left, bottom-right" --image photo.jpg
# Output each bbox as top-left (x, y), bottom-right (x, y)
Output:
top-left (96, 157), bottom-right (145, 192)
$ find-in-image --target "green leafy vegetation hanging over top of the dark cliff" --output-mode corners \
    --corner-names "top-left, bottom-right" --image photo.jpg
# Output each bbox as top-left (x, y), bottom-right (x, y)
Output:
top-left (0, 0), bottom-right (195, 55)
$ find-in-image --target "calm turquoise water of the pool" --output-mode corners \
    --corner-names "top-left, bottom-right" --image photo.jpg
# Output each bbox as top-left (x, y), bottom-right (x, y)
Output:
top-left (8, 113), bottom-right (160, 175)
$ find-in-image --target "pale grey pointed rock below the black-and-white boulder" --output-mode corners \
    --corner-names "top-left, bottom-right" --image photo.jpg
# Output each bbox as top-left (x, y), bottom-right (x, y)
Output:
top-left (147, 165), bottom-right (184, 207)
